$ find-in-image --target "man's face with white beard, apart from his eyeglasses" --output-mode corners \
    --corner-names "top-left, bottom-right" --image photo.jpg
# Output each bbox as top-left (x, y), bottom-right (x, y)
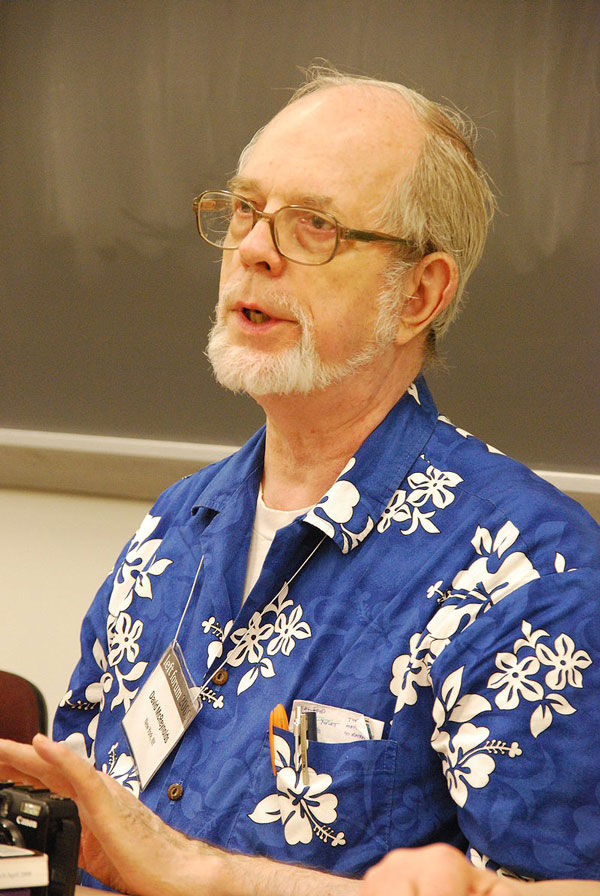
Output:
top-left (208, 87), bottom-right (420, 396)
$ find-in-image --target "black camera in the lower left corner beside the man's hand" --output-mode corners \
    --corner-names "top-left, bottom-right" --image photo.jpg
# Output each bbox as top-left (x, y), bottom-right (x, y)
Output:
top-left (0, 781), bottom-right (81, 896)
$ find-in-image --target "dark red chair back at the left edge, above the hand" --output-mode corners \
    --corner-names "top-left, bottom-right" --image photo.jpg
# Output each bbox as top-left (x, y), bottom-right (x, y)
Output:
top-left (0, 671), bottom-right (48, 744)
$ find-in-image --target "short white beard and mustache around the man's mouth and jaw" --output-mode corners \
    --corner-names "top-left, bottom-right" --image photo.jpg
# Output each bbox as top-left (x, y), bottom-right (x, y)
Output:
top-left (206, 285), bottom-right (401, 396)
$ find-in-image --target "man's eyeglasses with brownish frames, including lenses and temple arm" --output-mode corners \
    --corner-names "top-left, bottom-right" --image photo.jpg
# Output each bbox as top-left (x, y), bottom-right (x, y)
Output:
top-left (194, 190), bottom-right (416, 265)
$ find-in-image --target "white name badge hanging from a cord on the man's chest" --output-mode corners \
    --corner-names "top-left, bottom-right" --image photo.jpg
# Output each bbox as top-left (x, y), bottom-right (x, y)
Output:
top-left (122, 641), bottom-right (202, 790)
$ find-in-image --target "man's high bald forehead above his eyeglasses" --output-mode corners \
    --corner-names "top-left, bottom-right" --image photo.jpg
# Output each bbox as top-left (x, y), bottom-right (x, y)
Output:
top-left (240, 85), bottom-right (423, 215)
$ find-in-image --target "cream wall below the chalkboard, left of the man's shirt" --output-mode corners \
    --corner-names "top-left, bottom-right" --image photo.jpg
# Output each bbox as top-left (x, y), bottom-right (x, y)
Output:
top-left (0, 489), bottom-right (149, 722)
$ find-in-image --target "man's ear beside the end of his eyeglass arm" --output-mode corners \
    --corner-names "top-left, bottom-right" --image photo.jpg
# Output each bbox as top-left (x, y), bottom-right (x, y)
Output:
top-left (396, 252), bottom-right (458, 345)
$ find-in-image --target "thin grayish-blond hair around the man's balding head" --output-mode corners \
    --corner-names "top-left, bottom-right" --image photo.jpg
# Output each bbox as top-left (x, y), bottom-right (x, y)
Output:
top-left (238, 65), bottom-right (496, 354)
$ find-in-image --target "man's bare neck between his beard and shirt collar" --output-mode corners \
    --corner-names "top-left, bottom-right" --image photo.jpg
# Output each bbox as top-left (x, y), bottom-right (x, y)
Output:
top-left (258, 346), bottom-right (420, 510)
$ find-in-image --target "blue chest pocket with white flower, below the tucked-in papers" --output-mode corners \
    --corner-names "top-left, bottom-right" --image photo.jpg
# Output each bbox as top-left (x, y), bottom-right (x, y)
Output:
top-left (227, 728), bottom-right (398, 876)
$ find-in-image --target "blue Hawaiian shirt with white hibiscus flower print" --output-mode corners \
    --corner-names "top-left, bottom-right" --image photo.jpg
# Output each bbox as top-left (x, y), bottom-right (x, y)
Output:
top-left (54, 377), bottom-right (600, 878)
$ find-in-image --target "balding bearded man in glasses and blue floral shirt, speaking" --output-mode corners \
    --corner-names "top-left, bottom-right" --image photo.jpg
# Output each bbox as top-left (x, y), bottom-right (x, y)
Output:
top-left (16, 73), bottom-right (600, 893)
